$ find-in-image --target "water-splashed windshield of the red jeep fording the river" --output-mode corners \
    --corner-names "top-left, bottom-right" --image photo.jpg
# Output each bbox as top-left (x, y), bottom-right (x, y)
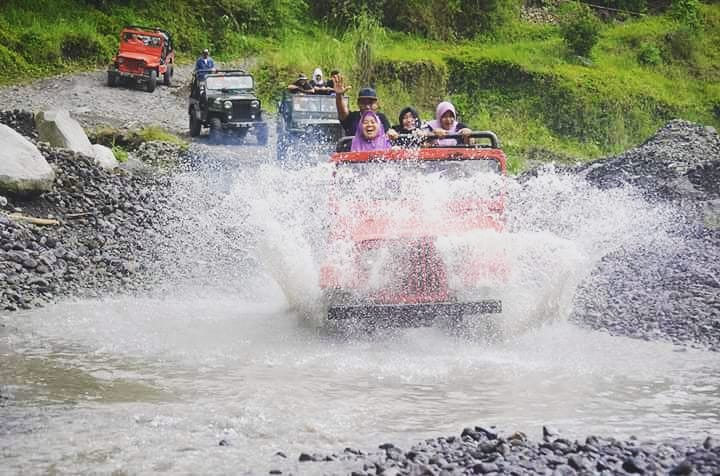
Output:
top-left (335, 159), bottom-right (503, 200)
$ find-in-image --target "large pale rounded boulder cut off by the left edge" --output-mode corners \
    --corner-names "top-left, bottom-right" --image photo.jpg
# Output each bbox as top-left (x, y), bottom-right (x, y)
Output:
top-left (0, 124), bottom-right (55, 195)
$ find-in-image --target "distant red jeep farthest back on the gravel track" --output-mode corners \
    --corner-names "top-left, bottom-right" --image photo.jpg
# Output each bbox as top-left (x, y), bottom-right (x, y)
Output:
top-left (108, 26), bottom-right (175, 93)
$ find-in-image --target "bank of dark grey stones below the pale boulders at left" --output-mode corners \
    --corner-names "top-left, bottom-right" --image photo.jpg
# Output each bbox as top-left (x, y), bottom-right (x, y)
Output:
top-left (0, 144), bottom-right (167, 310)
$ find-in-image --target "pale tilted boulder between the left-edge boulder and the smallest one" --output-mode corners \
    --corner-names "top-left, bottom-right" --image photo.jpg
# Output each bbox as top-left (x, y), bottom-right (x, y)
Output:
top-left (35, 109), bottom-right (94, 157)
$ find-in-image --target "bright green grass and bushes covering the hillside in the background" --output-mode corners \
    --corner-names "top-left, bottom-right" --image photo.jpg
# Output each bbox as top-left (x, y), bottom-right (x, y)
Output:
top-left (0, 0), bottom-right (720, 168)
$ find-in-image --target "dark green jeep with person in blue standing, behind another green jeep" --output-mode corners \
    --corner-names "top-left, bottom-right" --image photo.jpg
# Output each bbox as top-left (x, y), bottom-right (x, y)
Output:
top-left (188, 70), bottom-right (268, 145)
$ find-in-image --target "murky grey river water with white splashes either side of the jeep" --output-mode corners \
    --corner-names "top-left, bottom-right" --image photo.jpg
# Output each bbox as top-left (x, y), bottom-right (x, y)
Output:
top-left (0, 145), bottom-right (720, 474)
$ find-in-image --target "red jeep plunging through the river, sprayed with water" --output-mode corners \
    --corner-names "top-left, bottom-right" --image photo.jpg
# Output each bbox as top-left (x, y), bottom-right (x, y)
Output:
top-left (320, 132), bottom-right (508, 327)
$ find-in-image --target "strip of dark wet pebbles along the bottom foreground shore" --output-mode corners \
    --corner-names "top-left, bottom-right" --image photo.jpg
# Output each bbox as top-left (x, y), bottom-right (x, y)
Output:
top-left (290, 427), bottom-right (720, 476)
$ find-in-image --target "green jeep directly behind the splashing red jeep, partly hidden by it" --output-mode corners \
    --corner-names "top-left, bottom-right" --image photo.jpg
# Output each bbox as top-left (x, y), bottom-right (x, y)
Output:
top-left (277, 93), bottom-right (347, 161)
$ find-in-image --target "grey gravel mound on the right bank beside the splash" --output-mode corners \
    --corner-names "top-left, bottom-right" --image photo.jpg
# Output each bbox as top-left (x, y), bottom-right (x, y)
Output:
top-left (573, 120), bottom-right (720, 351)
